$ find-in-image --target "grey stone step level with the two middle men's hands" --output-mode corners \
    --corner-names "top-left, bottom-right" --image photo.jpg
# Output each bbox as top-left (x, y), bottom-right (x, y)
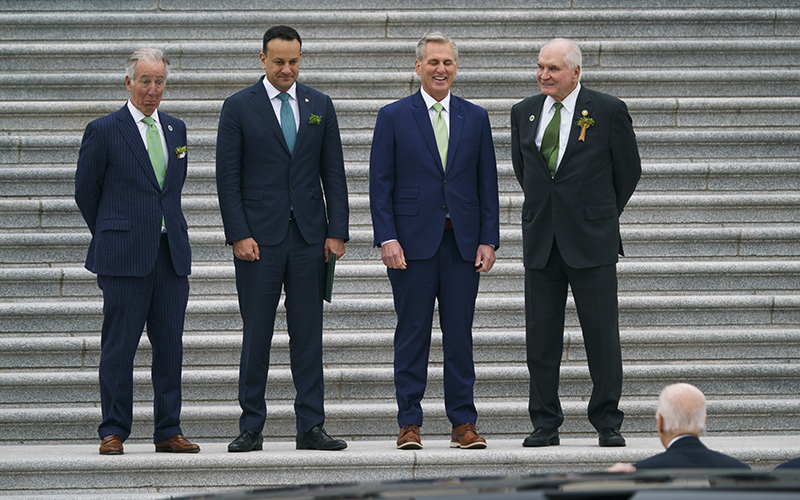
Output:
top-left (0, 224), bottom-right (800, 268)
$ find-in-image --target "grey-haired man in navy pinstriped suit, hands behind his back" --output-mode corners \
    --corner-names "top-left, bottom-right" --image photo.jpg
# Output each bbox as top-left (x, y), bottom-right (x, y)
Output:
top-left (75, 49), bottom-right (200, 455)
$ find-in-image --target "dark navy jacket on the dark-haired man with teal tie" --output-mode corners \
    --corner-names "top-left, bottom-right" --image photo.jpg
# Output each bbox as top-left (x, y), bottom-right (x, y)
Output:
top-left (217, 76), bottom-right (349, 246)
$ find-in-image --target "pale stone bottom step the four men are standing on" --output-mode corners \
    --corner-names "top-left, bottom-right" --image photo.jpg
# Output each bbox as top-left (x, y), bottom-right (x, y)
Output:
top-left (0, 435), bottom-right (800, 499)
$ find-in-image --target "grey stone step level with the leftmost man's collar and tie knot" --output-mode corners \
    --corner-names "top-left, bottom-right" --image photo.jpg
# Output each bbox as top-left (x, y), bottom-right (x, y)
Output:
top-left (6, 96), bottom-right (800, 135)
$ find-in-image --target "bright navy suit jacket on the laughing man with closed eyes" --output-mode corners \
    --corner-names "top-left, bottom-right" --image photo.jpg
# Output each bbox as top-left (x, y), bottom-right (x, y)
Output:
top-left (369, 91), bottom-right (500, 261)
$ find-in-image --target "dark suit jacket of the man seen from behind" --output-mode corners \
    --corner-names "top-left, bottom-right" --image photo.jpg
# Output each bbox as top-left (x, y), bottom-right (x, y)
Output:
top-left (634, 436), bottom-right (750, 470)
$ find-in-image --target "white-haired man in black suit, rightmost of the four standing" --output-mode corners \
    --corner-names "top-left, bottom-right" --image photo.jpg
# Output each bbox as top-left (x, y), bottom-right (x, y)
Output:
top-left (511, 39), bottom-right (641, 447)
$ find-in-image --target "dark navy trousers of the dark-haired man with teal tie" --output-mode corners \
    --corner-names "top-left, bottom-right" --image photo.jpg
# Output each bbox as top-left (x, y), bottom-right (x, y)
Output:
top-left (234, 220), bottom-right (325, 432)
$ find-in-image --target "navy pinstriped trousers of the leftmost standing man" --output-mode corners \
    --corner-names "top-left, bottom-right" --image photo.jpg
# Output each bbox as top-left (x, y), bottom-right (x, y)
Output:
top-left (97, 233), bottom-right (189, 443)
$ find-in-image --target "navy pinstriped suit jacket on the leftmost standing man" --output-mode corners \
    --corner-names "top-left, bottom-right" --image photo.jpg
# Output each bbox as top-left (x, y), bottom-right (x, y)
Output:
top-left (75, 105), bottom-right (192, 276)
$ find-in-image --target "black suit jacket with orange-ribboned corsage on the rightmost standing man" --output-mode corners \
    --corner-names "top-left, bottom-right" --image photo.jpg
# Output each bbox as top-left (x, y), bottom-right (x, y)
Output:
top-left (511, 87), bottom-right (642, 269)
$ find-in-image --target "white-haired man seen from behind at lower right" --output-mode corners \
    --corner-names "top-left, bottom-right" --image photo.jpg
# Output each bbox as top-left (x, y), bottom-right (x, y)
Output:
top-left (608, 384), bottom-right (750, 472)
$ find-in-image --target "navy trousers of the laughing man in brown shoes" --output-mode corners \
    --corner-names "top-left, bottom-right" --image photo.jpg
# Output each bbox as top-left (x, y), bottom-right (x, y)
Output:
top-left (388, 229), bottom-right (480, 427)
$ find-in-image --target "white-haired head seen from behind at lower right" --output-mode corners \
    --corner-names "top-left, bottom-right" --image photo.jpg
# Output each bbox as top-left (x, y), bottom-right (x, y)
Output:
top-left (658, 384), bottom-right (706, 436)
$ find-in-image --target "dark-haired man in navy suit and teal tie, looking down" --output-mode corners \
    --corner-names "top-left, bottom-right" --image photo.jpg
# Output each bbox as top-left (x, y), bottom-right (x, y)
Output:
top-left (217, 26), bottom-right (348, 452)
